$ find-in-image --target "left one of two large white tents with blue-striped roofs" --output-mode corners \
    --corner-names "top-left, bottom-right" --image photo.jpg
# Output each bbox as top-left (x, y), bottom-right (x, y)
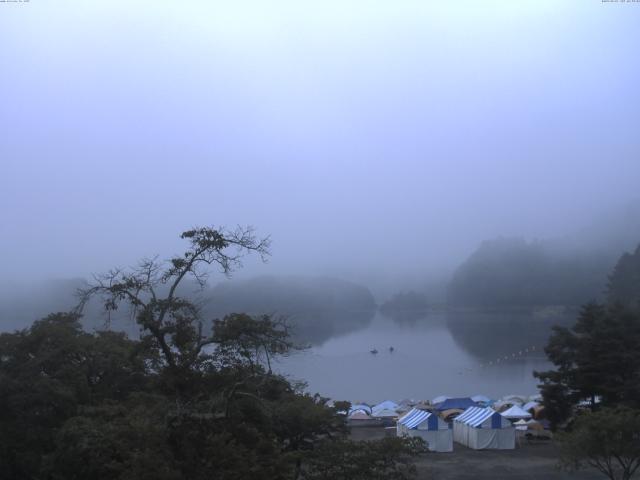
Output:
top-left (396, 408), bottom-right (453, 452)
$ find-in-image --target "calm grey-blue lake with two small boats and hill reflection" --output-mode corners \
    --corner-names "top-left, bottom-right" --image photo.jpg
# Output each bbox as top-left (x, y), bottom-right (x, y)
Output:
top-left (278, 312), bottom-right (575, 402)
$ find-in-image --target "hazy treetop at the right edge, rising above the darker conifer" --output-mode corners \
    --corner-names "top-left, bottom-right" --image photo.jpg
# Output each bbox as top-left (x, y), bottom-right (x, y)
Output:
top-left (607, 245), bottom-right (640, 310)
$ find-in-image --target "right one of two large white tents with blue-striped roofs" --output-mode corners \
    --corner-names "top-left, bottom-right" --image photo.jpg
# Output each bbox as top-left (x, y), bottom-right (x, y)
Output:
top-left (453, 407), bottom-right (516, 450)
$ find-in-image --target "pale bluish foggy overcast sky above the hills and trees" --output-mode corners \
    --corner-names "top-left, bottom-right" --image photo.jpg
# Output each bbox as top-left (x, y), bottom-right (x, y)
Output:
top-left (0, 0), bottom-right (640, 279)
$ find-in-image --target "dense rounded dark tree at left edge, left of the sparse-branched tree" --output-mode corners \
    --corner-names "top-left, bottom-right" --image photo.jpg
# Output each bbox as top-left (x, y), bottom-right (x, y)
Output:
top-left (0, 313), bottom-right (153, 478)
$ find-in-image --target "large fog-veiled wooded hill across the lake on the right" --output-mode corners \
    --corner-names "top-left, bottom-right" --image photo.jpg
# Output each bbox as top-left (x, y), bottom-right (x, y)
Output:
top-left (448, 202), bottom-right (640, 307)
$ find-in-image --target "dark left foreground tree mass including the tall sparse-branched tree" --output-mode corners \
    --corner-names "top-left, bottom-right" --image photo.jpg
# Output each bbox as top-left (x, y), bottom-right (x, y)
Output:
top-left (0, 228), bottom-right (430, 480)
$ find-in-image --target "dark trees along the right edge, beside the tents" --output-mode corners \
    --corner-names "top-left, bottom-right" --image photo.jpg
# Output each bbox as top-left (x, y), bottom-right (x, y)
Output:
top-left (535, 246), bottom-right (640, 480)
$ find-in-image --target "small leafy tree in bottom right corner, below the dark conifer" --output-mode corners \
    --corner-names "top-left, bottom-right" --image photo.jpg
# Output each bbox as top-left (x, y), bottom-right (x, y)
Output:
top-left (559, 408), bottom-right (640, 480)
